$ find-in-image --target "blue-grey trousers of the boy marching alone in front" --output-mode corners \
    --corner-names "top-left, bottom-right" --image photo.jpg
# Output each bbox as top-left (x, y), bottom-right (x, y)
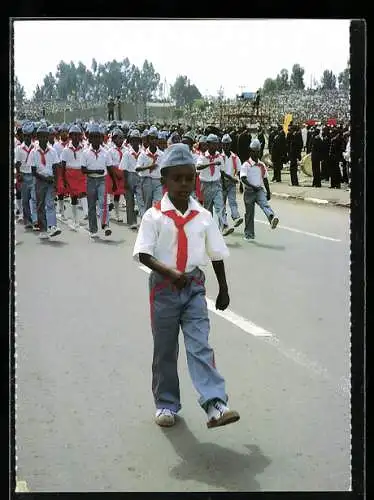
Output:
top-left (149, 268), bottom-right (228, 412)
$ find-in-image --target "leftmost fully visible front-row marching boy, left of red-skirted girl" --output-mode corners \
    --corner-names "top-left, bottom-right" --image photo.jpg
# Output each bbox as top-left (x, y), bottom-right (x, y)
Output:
top-left (29, 125), bottom-right (61, 239)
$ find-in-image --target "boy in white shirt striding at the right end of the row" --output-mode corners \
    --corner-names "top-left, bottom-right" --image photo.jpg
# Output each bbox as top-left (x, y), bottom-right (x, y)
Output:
top-left (240, 139), bottom-right (279, 241)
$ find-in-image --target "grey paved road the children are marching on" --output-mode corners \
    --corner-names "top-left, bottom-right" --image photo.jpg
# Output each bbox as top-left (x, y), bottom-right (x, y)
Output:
top-left (16, 200), bottom-right (350, 492)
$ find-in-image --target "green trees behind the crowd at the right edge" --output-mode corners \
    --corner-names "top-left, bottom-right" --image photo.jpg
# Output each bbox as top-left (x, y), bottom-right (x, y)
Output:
top-left (262, 61), bottom-right (350, 93)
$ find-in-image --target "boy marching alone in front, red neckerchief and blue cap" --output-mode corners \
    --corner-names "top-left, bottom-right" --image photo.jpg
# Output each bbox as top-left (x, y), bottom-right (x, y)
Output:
top-left (133, 144), bottom-right (240, 428)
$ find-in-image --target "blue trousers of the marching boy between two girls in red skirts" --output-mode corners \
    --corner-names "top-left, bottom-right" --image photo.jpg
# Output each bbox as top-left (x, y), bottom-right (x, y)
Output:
top-left (87, 176), bottom-right (109, 233)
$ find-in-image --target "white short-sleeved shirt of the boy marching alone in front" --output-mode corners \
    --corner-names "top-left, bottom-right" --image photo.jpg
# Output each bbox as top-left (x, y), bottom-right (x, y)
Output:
top-left (133, 193), bottom-right (230, 272)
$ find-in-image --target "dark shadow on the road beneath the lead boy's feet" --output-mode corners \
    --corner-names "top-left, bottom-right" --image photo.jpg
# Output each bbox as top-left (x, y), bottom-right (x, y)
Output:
top-left (162, 418), bottom-right (271, 491)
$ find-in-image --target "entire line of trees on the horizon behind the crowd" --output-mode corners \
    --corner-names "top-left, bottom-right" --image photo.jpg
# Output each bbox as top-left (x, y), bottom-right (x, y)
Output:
top-left (14, 57), bottom-right (349, 108)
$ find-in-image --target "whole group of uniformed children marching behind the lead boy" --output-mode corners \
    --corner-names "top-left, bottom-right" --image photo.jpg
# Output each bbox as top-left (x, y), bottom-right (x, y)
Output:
top-left (15, 122), bottom-right (278, 241)
